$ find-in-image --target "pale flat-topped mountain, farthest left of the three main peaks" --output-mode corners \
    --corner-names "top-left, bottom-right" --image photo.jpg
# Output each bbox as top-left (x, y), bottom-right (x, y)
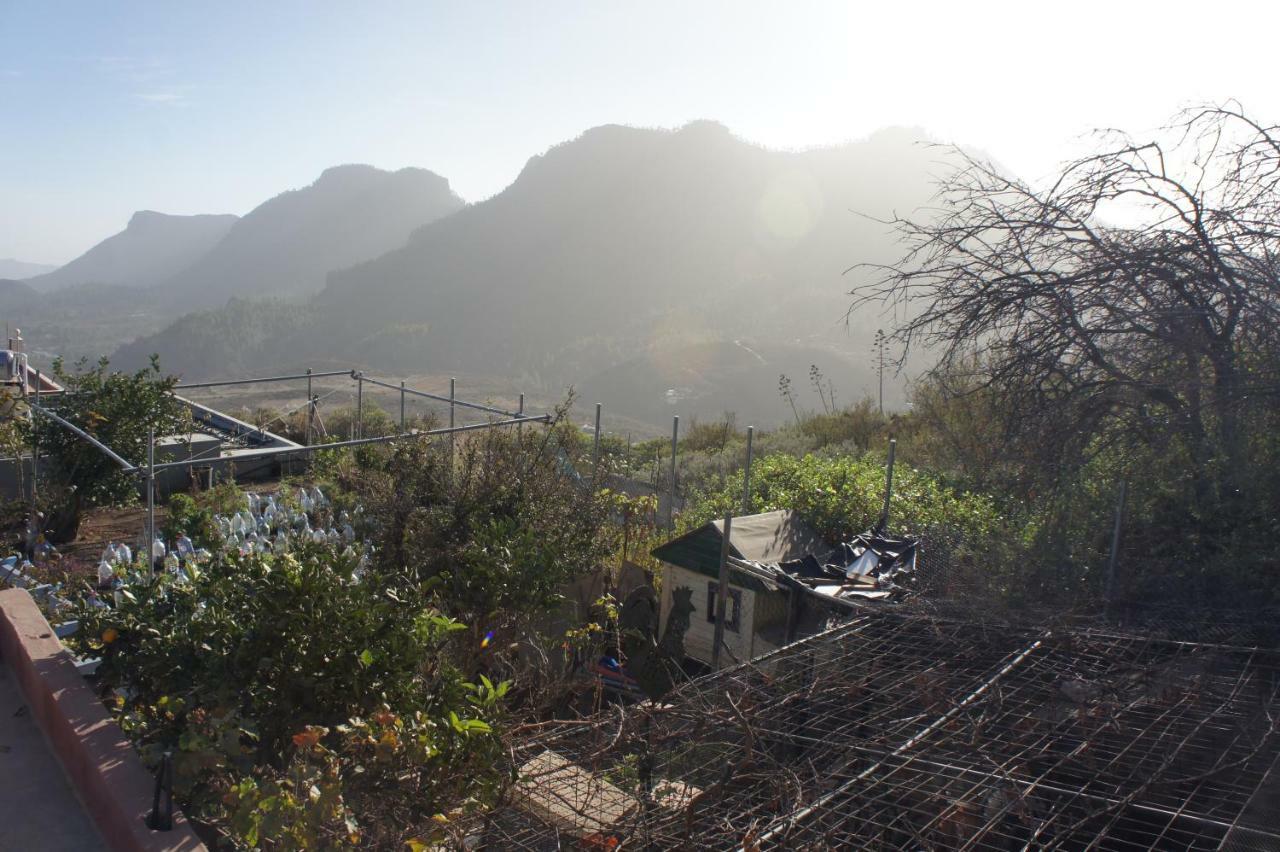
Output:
top-left (27, 210), bottom-right (236, 292)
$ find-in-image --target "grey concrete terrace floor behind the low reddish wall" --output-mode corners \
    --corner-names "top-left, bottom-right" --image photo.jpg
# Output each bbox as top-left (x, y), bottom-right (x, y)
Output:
top-left (0, 665), bottom-right (108, 852)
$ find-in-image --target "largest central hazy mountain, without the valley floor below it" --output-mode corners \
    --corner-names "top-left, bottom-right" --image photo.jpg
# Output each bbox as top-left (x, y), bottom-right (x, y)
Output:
top-left (308, 123), bottom-right (928, 377)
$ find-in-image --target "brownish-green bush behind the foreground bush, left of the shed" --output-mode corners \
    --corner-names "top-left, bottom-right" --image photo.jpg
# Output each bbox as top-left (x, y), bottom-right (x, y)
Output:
top-left (343, 429), bottom-right (617, 632)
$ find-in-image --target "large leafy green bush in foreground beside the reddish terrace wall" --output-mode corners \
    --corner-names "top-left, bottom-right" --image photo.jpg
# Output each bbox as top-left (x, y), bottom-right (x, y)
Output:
top-left (72, 546), bottom-right (508, 848)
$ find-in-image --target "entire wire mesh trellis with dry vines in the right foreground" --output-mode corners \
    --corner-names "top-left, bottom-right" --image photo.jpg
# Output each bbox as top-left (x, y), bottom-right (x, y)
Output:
top-left (454, 613), bottom-right (1280, 849)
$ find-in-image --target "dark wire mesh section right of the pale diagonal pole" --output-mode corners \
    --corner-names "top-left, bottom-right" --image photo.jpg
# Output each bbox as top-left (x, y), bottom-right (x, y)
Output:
top-left (769, 626), bottom-right (1280, 849)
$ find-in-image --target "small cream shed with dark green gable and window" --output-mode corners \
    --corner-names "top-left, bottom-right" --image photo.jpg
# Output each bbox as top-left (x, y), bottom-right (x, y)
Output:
top-left (653, 509), bottom-right (831, 665)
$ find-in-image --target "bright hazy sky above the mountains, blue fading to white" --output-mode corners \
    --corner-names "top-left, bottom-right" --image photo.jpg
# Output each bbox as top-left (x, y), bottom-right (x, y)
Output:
top-left (0, 0), bottom-right (1280, 262)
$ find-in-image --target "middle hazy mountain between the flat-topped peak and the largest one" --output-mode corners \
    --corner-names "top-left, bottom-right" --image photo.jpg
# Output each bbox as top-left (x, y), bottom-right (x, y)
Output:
top-left (165, 165), bottom-right (463, 310)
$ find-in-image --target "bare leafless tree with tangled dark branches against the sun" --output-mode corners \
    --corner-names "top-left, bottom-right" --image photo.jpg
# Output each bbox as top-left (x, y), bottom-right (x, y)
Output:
top-left (854, 104), bottom-right (1280, 496)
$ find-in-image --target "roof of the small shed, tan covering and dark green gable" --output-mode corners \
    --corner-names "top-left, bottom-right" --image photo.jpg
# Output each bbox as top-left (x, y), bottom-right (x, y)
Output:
top-left (653, 509), bottom-right (831, 582)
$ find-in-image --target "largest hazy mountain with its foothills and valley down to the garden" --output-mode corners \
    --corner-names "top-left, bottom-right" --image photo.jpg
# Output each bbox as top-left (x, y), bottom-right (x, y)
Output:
top-left (120, 122), bottom-right (937, 425)
